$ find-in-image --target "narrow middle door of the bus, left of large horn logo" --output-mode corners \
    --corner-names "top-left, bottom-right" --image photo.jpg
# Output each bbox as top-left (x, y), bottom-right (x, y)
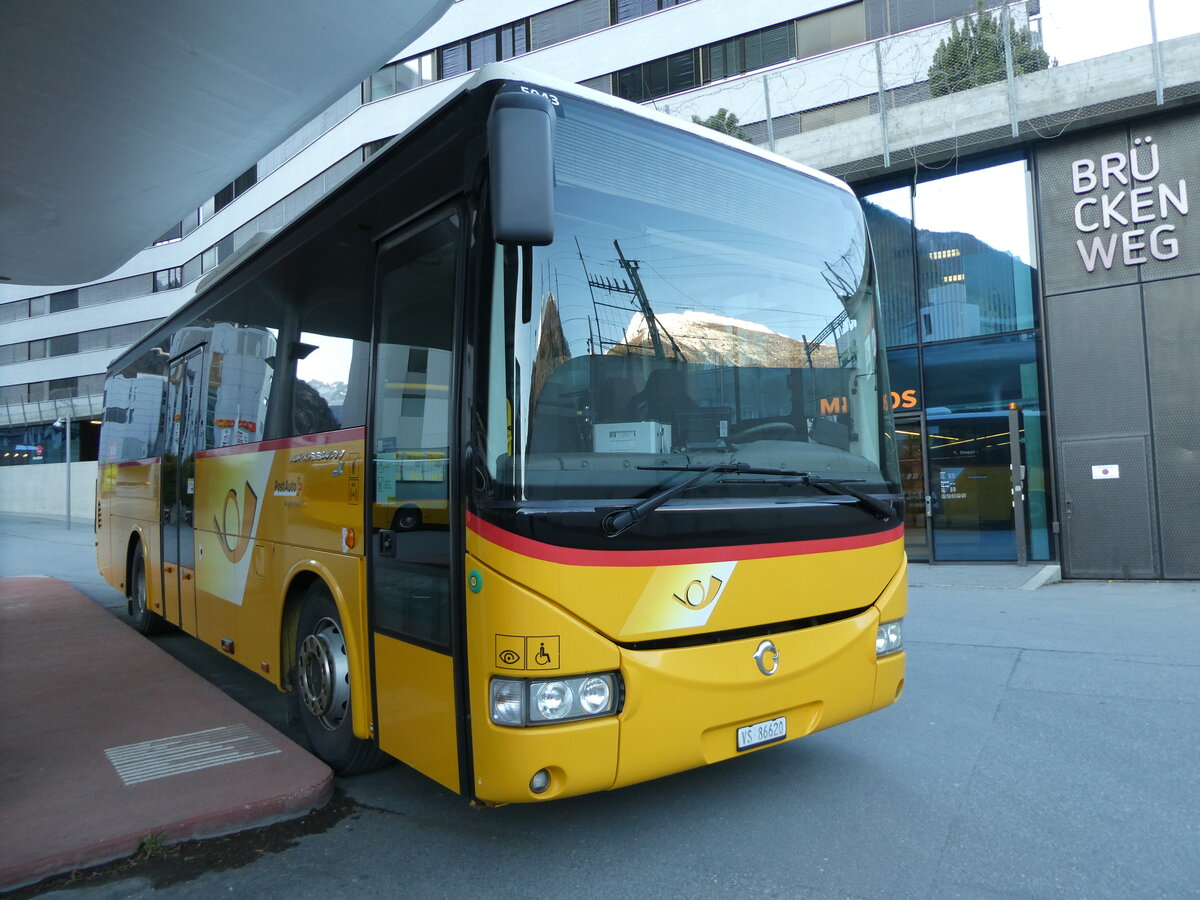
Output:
top-left (160, 347), bottom-right (204, 634)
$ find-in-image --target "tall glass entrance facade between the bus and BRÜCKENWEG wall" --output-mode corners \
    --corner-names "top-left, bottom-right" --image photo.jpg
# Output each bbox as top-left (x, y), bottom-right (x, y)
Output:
top-left (863, 157), bottom-right (1050, 562)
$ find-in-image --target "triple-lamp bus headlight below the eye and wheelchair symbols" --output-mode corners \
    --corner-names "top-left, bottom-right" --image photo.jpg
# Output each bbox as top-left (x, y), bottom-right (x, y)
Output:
top-left (491, 672), bottom-right (620, 727)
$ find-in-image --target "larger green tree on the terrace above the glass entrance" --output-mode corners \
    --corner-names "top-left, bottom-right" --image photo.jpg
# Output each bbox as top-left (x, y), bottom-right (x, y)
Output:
top-left (929, 0), bottom-right (1050, 97)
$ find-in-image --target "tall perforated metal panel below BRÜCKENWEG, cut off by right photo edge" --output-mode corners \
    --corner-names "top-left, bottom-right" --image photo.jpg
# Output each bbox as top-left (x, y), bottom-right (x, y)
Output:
top-left (1145, 276), bottom-right (1200, 578)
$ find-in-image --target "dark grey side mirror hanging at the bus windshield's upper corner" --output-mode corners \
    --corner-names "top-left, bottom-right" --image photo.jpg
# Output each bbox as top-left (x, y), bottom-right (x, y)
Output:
top-left (487, 91), bottom-right (554, 245)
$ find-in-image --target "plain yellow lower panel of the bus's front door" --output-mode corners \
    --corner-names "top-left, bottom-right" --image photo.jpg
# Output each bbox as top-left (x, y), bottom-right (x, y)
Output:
top-left (374, 634), bottom-right (458, 793)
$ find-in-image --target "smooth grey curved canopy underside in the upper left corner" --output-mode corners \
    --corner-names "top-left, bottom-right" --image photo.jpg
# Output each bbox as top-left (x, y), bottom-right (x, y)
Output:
top-left (0, 0), bottom-right (454, 284)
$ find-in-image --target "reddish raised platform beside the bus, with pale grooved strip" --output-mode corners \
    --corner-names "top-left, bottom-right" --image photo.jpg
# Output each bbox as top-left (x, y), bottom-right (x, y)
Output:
top-left (0, 577), bottom-right (334, 890)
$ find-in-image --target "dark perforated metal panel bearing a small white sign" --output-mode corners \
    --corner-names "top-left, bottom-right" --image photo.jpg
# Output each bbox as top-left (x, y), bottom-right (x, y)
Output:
top-left (1058, 438), bottom-right (1159, 578)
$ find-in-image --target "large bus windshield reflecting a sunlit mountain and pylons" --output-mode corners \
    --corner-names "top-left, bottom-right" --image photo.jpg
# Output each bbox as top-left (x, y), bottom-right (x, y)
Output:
top-left (486, 98), bottom-right (899, 511)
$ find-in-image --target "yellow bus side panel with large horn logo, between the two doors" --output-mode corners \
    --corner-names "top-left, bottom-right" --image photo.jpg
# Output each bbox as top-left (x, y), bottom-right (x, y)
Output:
top-left (189, 441), bottom-right (371, 738)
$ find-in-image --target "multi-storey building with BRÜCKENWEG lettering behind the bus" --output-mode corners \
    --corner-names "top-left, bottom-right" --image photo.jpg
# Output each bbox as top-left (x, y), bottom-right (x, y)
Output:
top-left (0, 0), bottom-right (1200, 578)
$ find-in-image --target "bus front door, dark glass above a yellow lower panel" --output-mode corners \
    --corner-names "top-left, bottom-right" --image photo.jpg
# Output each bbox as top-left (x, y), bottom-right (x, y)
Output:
top-left (368, 212), bottom-right (462, 791)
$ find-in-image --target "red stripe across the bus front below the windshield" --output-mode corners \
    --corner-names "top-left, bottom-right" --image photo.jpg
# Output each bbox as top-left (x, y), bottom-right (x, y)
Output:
top-left (467, 512), bottom-right (904, 566)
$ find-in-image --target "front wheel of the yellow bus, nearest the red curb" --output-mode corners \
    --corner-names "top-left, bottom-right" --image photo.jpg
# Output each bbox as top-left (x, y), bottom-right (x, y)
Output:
top-left (293, 581), bottom-right (389, 775)
